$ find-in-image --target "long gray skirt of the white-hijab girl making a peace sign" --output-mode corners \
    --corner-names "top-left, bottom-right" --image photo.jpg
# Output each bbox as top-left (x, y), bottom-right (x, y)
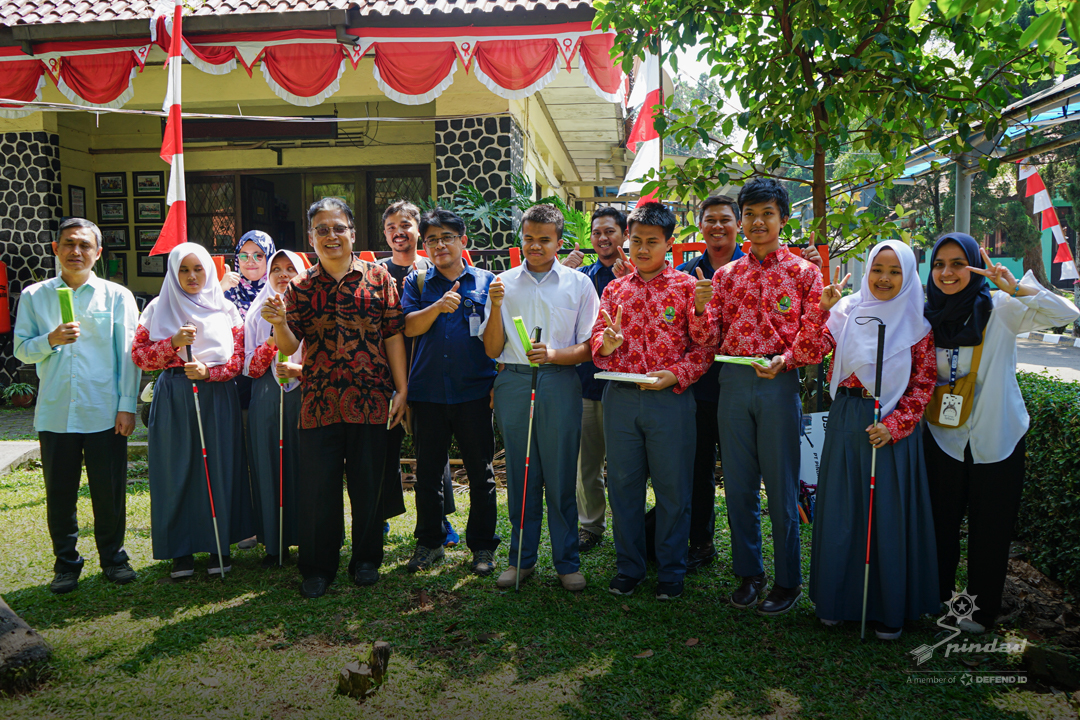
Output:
top-left (810, 395), bottom-right (939, 627)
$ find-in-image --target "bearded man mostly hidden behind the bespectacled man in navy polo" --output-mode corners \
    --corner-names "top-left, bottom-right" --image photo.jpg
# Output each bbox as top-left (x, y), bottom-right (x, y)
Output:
top-left (376, 200), bottom-right (460, 547)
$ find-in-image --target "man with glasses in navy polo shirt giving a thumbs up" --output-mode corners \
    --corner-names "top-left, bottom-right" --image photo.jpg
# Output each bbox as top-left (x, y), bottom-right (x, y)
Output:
top-left (402, 209), bottom-right (499, 575)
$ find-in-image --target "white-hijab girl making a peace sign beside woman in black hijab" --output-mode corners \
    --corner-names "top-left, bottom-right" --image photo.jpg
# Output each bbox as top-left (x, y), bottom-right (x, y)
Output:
top-left (810, 240), bottom-right (939, 640)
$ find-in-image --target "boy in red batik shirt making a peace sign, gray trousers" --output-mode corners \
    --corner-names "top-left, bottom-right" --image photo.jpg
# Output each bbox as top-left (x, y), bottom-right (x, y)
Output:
top-left (592, 203), bottom-right (713, 600)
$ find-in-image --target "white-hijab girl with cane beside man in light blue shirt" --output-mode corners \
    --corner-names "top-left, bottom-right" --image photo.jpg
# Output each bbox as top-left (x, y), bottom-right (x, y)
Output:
top-left (132, 243), bottom-right (254, 578)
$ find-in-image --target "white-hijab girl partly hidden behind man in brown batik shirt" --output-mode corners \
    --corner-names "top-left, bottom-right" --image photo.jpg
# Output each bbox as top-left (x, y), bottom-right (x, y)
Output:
top-left (244, 250), bottom-right (307, 569)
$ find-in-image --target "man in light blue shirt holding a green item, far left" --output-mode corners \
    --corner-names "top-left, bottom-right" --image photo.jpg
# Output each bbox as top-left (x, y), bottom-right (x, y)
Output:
top-left (15, 218), bottom-right (140, 594)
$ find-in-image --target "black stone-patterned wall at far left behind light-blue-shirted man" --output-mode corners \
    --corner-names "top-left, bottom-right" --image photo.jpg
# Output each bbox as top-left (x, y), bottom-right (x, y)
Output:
top-left (0, 132), bottom-right (63, 384)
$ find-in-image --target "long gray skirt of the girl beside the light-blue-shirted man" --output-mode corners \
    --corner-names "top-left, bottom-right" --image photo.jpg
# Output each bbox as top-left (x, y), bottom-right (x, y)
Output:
top-left (149, 368), bottom-right (255, 560)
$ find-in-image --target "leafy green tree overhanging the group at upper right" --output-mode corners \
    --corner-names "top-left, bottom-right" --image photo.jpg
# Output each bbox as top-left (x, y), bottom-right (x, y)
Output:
top-left (596, 0), bottom-right (1069, 255)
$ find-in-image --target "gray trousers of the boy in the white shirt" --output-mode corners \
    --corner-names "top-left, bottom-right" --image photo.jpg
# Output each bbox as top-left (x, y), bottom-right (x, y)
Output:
top-left (495, 365), bottom-right (581, 575)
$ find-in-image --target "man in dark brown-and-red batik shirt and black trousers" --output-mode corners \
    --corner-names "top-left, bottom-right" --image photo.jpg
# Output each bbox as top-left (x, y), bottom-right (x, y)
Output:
top-left (262, 198), bottom-right (408, 598)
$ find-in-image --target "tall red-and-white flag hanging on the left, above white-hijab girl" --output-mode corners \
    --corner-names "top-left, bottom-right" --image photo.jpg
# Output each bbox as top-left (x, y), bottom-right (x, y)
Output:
top-left (150, 0), bottom-right (188, 255)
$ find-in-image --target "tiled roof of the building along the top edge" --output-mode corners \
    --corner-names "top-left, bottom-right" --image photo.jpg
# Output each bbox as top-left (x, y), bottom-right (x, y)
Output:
top-left (0, 0), bottom-right (592, 26)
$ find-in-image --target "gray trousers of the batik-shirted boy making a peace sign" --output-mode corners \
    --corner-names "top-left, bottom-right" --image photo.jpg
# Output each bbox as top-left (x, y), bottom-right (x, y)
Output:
top-left (604, 382), bottom-right (698, 583)
